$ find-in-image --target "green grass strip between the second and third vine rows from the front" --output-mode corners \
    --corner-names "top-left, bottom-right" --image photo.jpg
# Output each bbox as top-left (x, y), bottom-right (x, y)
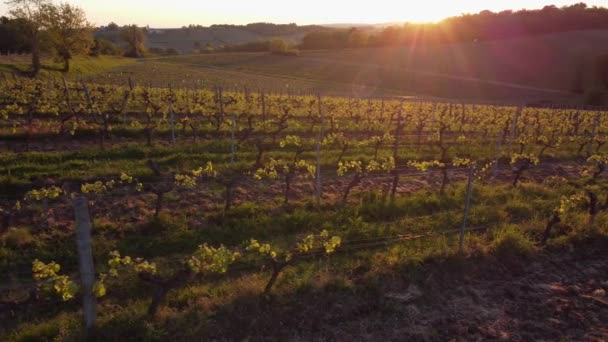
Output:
top-left (0, 115), bottom-right (592, 190)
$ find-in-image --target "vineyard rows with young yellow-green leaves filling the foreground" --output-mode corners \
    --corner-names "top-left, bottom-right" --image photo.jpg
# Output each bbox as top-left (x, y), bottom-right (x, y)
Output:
top-left (0, 75), bottom-right (608, 340)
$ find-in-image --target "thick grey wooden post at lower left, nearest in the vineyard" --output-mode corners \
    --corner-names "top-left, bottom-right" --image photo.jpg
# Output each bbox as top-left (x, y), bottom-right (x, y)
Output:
top-left (72, 196), bottom-right (96, 331)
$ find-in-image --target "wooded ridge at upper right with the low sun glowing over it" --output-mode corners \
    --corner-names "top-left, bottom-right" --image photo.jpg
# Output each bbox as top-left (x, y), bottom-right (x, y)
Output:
top-left (300, 3), bottom-right (608, 49)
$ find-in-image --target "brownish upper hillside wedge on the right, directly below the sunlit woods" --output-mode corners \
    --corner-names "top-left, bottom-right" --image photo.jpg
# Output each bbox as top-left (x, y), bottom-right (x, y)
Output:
top-left (312, 30), bottom-right (608, 90)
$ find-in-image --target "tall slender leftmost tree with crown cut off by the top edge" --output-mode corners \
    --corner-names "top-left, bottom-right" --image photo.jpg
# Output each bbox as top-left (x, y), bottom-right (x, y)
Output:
top-left (7, 0), bottom-right (52, 75)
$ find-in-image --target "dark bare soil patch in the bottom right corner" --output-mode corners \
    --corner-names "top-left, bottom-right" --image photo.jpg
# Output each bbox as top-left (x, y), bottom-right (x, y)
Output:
top-left (207, 241), bottom-right (608, 342)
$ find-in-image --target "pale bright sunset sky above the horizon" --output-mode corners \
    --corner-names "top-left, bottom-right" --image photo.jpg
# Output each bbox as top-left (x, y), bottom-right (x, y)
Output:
top-left (0, 0), bottom-right (608, 28)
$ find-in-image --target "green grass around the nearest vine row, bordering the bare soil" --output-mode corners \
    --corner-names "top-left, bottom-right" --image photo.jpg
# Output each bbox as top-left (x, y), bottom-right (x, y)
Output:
top-left (0, 170), bottom-right (608, 341)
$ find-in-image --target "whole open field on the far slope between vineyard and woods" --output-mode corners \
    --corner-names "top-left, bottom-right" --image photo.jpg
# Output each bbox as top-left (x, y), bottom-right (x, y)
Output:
top-left (84, 31), bottom-right (608, 103)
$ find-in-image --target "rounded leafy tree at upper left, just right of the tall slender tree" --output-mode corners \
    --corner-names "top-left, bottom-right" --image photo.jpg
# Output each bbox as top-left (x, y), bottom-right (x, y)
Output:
top-left (44, 3), bottom-right (93, 72)
